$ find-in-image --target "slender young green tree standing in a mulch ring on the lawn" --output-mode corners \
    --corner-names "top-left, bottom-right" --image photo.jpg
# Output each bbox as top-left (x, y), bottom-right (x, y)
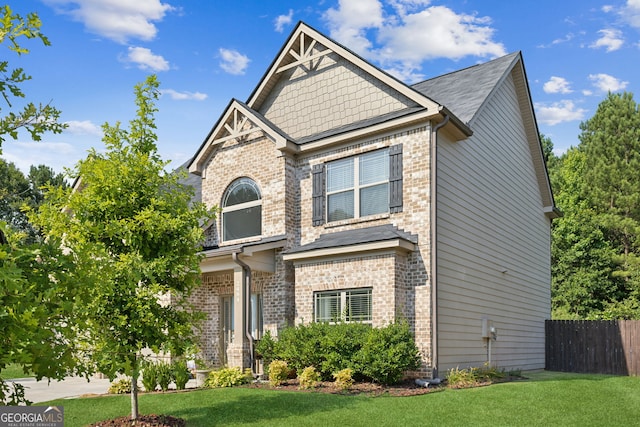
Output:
top-left (37, 76), bottom-right (209, 419)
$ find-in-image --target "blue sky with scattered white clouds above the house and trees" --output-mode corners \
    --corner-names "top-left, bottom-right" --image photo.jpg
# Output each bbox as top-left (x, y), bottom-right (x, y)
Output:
top-left (0, 0), bottom-right (640, 172)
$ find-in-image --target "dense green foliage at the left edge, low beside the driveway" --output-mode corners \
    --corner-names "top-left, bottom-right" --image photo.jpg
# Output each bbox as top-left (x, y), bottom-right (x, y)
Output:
top-left (0, 221), bottom-right (97, 404)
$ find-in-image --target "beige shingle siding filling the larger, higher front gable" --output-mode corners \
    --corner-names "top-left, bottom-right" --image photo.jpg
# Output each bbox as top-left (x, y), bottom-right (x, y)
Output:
top-left (259, 54), bottom-right (416, 138)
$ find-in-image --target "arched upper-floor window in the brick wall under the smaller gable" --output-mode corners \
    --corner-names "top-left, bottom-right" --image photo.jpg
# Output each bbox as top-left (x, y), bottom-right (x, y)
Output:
top-left (222, 178), bottom-right (262, 241)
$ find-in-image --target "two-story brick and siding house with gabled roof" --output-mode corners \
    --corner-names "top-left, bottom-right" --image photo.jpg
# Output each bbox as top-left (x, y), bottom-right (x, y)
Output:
top-left (188, 23), bottom-right (557, 373)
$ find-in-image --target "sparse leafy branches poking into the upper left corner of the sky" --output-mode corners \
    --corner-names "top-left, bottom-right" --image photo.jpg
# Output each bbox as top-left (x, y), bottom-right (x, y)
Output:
top-left (0, 5), bottom-right (65, 150)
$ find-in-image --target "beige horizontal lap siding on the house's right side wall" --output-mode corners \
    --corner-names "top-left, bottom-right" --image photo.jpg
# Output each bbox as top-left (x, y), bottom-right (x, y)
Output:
top-left (437, 72), bottom-right (551, 373)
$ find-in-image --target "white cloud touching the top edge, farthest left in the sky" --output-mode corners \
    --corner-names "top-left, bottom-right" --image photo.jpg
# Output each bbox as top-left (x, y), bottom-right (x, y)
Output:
top-left (45, 0), bottom-right (175, 44)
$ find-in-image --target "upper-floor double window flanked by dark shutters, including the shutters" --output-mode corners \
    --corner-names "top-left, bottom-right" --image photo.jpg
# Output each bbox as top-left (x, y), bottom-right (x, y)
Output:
top-left (313, 144), bottom-right (402, 225)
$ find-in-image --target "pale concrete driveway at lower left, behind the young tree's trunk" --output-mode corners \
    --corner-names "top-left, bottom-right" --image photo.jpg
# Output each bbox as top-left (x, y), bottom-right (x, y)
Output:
top-left (8, 377), bottom-right (196, 405)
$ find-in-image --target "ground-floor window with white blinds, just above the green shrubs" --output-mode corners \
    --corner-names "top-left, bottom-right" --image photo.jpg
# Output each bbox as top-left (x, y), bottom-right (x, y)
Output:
top-left (313, 288), bottom-right (372, 323)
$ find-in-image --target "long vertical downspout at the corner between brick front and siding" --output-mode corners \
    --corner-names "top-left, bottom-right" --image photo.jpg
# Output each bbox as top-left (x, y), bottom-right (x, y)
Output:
top-left (430, 111), bottom-right (450, 378)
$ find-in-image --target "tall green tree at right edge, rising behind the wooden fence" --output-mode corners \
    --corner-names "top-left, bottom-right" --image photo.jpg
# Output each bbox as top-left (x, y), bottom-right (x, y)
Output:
top-left (580, 92), bottom-right (640, 317)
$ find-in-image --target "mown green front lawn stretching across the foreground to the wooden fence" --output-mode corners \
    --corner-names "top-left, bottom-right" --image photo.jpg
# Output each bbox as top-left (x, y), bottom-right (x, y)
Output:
top-left (47, 372), bottom-right (640, 427)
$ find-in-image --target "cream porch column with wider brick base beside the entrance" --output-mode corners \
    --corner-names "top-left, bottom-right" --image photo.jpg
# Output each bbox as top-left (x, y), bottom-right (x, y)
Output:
top-left (227, 266), bottom-right (251, 370)
